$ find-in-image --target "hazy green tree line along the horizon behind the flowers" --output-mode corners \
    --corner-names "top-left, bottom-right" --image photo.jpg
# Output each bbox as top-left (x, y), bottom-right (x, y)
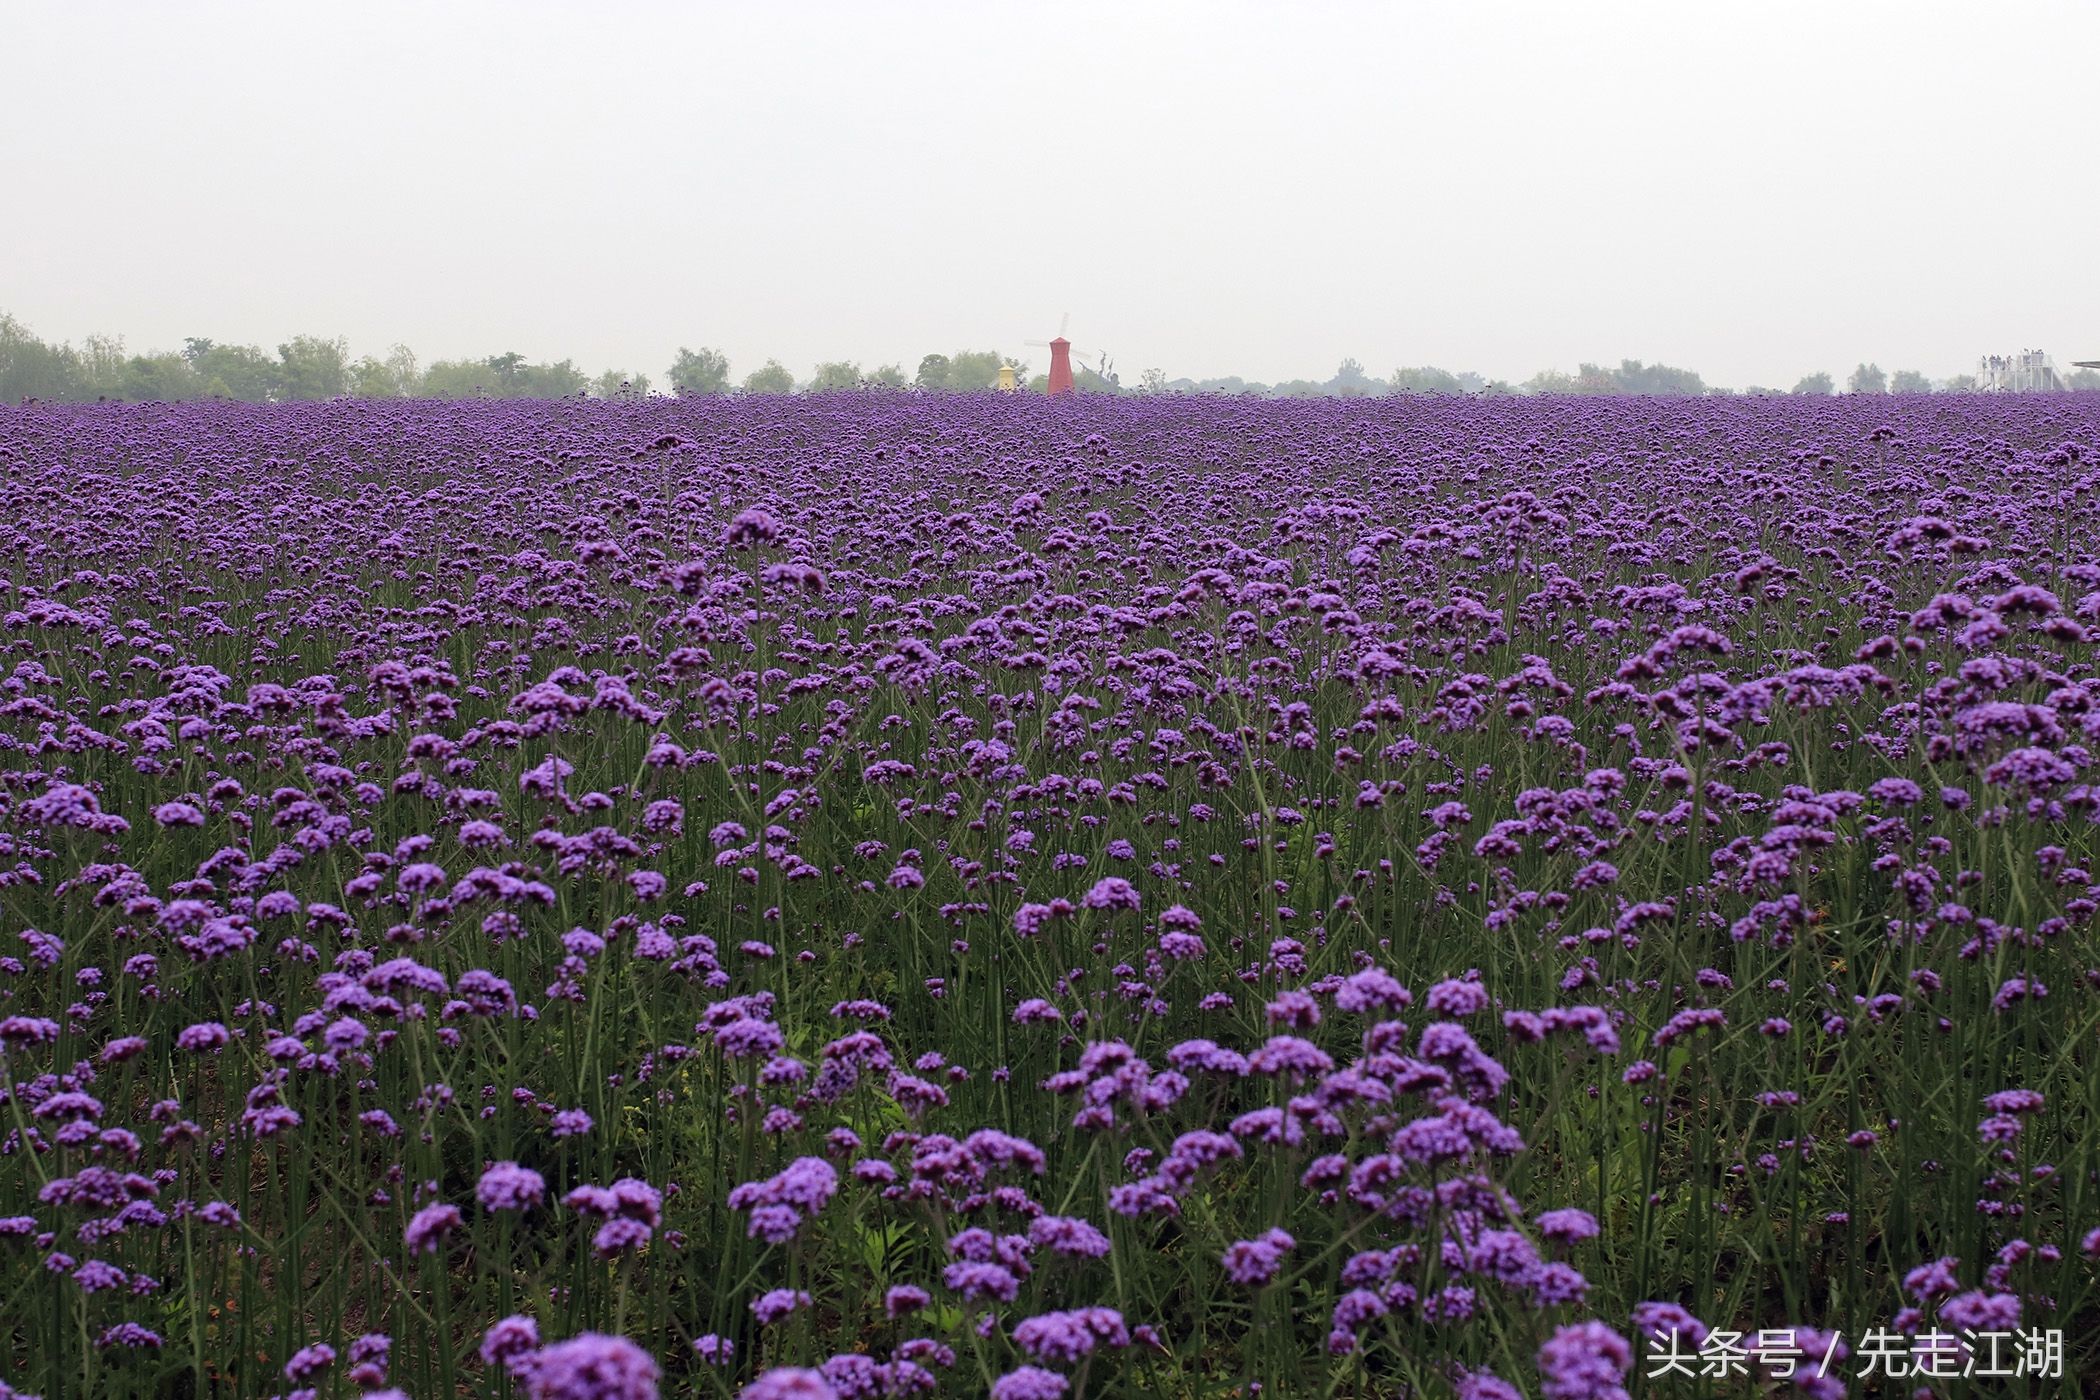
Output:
top-left (0, 313), bottom-right (2100, 403)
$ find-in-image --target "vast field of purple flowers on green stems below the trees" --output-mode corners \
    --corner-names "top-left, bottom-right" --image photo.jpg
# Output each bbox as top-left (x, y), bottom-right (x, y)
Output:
top-left (0, 393), bottom-right (2100, 1400)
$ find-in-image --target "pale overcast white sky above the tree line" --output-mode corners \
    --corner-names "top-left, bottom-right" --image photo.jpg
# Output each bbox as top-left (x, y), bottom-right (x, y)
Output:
top-left (0, 0), bottom-right (2100, 386)
